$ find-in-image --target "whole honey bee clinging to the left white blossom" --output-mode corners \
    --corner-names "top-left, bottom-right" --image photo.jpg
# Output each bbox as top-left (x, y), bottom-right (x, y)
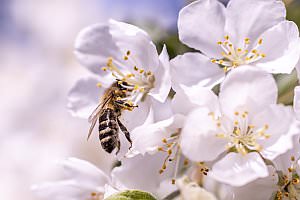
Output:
top-left (87, 80), bottom-right (137, 154)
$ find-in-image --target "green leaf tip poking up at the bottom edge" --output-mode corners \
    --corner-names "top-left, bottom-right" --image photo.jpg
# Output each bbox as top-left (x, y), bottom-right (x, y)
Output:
top-left (105, 190), bottom-right (157, 200)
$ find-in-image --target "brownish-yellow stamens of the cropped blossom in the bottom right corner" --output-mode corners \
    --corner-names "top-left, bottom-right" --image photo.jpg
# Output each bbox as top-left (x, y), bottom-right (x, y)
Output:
top-left (275, 156), bottom-right (300, 200)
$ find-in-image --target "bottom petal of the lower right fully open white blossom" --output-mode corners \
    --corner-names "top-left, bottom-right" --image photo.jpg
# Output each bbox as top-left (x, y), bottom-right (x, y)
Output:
top-left (210, 153), bottom-right (269, 186)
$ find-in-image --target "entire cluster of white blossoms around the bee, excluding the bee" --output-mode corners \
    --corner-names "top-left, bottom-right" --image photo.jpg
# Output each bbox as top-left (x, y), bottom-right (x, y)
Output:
top-left (33, 0), bottom-right (300, 200)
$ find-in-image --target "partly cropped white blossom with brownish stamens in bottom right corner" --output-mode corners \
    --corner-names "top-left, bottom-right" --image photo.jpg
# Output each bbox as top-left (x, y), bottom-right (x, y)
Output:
top-left (221, 130), bottom-right (300, 200)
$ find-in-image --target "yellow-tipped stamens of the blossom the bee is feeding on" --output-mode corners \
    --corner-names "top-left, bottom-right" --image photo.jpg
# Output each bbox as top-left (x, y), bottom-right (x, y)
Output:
top-left (102, 51), bottom-right (155, 106)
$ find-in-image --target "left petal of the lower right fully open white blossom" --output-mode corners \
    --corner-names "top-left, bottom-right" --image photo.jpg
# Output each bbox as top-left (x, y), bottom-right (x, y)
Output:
top-left (181, 108), bottom-right (226, 161)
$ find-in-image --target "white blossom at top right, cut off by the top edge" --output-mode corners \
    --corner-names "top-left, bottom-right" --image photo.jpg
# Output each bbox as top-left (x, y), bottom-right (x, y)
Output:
top-left (171, 0), bottom-right (300, 88)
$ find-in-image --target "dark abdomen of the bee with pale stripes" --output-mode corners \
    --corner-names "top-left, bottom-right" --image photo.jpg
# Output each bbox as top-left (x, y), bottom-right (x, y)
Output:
top-left (99, 108), bottom-right (120, 153)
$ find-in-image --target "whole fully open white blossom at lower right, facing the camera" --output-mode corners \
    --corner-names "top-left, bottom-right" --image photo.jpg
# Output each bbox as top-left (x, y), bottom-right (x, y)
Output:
top-left (181, 66), bottom-right (293, 186)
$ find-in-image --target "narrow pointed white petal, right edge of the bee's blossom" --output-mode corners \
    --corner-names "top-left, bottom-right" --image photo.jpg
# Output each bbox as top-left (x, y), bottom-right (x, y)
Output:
top-left (149, 45), bottom-right (171, 103)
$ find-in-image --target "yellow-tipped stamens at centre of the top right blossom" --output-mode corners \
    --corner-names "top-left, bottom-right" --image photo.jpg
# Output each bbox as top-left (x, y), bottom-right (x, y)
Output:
top-left (211, 35), bottom-right (266, 72)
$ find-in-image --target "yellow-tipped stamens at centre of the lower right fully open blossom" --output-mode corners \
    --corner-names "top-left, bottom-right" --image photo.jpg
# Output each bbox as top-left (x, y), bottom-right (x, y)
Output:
top-left (211, 111), bottom-right (271, 155)
